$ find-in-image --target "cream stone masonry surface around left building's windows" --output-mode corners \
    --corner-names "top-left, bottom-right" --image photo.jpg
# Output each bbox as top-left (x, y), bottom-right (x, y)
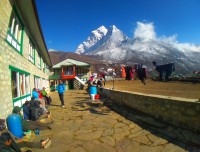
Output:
top-left (0, 0), bottom-right (48, 118)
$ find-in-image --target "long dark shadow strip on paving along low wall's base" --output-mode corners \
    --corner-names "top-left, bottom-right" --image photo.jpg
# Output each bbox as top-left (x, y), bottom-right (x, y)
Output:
top-left (103, 99), bottom-right (200, 152)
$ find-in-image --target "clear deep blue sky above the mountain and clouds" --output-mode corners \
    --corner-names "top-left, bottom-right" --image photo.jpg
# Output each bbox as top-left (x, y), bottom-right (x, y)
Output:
top-left (36, 0), bottom-right (200, 52)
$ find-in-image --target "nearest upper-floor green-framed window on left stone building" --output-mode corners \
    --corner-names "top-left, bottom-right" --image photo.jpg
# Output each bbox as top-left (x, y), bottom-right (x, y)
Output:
top-left (6, 11), bottom-right (23, 53)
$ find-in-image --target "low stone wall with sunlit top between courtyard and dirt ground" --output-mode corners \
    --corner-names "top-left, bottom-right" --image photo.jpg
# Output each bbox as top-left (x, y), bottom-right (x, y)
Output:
top-left (100, 89), bottom-right (200, 131)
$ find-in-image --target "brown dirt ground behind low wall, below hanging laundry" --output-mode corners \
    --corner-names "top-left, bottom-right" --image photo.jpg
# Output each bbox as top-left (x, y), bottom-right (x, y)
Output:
top-left (105, 80), bottom-right (200, 99)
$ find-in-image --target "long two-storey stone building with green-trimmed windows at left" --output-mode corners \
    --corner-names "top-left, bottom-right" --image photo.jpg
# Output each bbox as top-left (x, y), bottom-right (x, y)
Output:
top-left (0, 0), bottom-right (52, 118)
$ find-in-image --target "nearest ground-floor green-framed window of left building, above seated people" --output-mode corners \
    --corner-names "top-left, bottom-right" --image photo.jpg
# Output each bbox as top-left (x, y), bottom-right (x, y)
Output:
top-left (10, 66), bottom-right (30, 98)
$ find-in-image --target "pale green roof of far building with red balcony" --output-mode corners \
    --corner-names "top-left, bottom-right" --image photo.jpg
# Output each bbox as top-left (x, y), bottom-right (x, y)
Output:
top-left (52, 59), bottom-right (90, 69)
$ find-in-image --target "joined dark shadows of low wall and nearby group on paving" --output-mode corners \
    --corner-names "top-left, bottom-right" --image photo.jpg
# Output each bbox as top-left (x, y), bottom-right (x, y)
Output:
top-left (72, 95), bottom-right (200, 152)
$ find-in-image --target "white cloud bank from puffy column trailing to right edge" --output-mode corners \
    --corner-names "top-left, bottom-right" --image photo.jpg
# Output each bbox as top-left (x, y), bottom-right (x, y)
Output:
top-left (134, 22), bottom-right (200, 52)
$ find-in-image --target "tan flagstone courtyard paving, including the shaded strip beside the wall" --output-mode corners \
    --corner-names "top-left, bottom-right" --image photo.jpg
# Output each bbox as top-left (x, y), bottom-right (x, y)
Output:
top-left (32, 90), bottom-right (200, 152)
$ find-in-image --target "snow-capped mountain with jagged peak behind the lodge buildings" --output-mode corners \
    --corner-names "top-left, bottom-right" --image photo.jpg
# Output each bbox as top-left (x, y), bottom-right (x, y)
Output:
top-left (75, 23), bottom-right (200, 73)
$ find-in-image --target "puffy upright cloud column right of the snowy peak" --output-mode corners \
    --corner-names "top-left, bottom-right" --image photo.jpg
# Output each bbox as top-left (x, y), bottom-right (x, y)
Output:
top-left (134, 22), bottom-right (156, 42)
